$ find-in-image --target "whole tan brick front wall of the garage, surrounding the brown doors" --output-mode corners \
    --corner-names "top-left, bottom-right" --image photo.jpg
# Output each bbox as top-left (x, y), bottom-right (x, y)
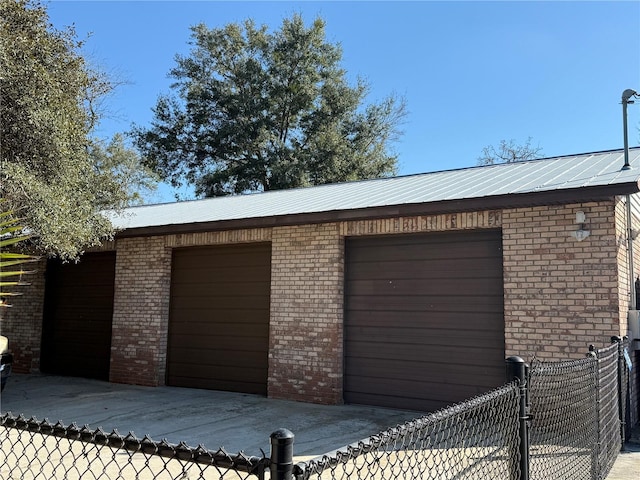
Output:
top-left (3, 199), bottom-right (640, 403)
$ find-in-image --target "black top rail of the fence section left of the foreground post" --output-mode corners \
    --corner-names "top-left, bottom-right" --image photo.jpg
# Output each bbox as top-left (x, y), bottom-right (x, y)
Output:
top-left (0, 412), bottom-right (269, 475)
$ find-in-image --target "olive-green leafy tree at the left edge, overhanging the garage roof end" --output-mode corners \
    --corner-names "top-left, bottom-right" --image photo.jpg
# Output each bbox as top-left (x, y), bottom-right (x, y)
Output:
top-left (0, 0), bottom-right (155, 259)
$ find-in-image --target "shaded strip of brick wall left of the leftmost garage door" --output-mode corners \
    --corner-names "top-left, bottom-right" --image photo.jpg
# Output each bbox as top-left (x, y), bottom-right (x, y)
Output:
top-left (0, 259), bottom-right (47, 373)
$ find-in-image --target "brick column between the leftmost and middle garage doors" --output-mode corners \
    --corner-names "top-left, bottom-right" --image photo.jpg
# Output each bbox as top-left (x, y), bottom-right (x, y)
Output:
top-left (109, 237), bottom-right (171, 386)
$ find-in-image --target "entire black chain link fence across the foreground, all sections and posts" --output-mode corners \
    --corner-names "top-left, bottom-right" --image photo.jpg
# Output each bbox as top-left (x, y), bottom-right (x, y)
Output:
top-left (0, 339), bottom-right (631, 480)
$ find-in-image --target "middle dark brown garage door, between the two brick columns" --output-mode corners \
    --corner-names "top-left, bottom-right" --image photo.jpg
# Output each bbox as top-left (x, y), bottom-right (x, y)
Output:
top-left (167, 244), bottom-right (271, 395)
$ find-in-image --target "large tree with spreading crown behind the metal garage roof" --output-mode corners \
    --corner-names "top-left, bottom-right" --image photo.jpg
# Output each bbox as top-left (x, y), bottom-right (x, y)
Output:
top-left (133, 15), bottom-right (405, 197)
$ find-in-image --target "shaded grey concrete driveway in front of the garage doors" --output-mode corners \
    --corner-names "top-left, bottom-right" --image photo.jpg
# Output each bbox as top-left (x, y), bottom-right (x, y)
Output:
top-left (0, 374), bottom-right (421, 459)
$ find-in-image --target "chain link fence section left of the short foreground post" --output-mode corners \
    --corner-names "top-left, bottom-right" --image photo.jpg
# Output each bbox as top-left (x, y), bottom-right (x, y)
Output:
top-left (0, 413), bottom-right (269, 480)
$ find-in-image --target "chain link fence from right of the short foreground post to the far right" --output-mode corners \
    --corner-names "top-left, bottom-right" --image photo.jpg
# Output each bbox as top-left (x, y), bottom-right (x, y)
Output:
top-left (294, 339), bottom-right (629, 480)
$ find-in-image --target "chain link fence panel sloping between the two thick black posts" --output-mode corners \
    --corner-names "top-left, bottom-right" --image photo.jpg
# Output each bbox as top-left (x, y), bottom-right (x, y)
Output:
top-left (294, 383), bottom-right (519, 480)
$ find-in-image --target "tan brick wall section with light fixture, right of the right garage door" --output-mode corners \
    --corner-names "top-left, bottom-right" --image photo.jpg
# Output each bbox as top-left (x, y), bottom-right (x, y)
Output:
top-left (502, 201), bottom-right (620, 360)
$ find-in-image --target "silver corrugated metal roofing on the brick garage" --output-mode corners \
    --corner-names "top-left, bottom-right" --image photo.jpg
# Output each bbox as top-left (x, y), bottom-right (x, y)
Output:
top-left (112, 147), bottom-right (640, 229)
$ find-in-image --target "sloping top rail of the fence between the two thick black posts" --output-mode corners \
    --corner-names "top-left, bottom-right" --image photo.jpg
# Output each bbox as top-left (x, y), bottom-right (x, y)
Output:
top-left (294, 381), bottom-right (519, 478)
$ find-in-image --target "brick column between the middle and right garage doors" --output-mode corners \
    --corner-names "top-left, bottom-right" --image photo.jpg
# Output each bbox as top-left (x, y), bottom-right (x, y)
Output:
top-left (268, 224), bottom-right (344, 404)
